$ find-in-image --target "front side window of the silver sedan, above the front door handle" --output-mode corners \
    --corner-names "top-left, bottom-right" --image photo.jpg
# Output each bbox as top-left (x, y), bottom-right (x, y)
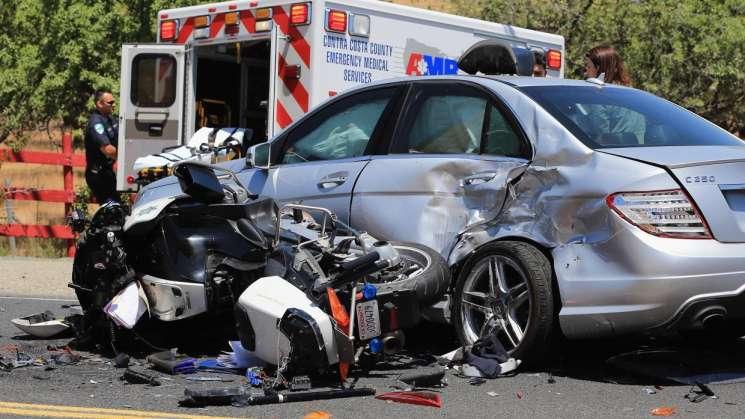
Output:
top-left (280, 88), bottom-right (396, 163)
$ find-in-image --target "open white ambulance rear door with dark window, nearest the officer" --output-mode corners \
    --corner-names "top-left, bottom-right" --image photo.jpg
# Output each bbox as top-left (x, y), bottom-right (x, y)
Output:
top-left (116, 44), bottom-right (186, 191)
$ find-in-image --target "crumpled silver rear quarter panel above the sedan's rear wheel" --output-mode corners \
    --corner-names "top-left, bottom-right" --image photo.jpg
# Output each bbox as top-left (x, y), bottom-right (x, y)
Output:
top-left (436, 80), bottom-right (692, 337)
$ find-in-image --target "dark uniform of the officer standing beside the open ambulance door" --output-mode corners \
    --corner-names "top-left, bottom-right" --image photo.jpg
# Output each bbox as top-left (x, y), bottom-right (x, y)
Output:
top-left (85, 110), bottom-right (119, 204)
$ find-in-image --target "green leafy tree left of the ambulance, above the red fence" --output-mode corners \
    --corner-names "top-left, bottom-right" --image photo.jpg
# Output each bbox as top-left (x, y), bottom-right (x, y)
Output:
top-left (0, 0), bottom-right (198, 148)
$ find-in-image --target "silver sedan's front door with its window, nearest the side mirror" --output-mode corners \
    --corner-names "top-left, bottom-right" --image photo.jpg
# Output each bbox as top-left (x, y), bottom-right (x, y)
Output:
top-left (261, 86), bottom-right (401, 222)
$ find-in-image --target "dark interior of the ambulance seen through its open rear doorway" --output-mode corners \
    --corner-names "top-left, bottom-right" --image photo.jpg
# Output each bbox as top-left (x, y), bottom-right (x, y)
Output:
top-left (194, 40), bottom-right (270, 146)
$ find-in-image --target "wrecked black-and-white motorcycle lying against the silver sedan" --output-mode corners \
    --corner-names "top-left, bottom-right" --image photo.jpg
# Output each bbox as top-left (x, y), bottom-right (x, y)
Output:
top-left (70, 162), bottom-right (449, 360)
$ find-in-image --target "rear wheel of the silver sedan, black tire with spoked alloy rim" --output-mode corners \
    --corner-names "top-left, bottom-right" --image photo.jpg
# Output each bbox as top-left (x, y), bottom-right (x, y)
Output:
top-left (452, 241), bottom-right (555, 364)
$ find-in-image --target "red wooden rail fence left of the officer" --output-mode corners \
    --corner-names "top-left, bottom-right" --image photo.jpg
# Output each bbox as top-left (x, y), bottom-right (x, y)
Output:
top-left (0, 132), bottom-right (85, 257)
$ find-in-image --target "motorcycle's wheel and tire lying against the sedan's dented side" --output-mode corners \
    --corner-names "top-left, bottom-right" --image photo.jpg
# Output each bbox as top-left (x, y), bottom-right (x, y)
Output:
top-left (364, 242), bottom-right (450, 305)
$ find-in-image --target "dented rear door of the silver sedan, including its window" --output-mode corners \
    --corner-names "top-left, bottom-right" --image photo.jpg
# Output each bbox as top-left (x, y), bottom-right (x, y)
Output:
top-left (350, 80), bottom-right (531, 257)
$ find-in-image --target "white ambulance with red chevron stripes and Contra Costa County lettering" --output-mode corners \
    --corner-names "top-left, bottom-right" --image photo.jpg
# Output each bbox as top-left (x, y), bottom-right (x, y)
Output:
top-left (117, 0), bottom-right (564, 191)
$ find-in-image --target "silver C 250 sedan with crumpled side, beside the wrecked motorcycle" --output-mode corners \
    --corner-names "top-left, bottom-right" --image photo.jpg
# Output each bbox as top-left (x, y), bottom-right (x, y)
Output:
top-left (137, 76), bottom-right (745, 360)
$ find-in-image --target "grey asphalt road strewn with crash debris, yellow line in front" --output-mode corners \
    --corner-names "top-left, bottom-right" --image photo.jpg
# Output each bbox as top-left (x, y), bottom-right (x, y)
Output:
top-left (0, 259), bottom-right (745, 418)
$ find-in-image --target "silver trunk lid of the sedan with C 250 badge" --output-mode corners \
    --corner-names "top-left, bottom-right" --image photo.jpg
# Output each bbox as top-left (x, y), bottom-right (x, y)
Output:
top-left (598, 145), bottom-right (745, 243)
